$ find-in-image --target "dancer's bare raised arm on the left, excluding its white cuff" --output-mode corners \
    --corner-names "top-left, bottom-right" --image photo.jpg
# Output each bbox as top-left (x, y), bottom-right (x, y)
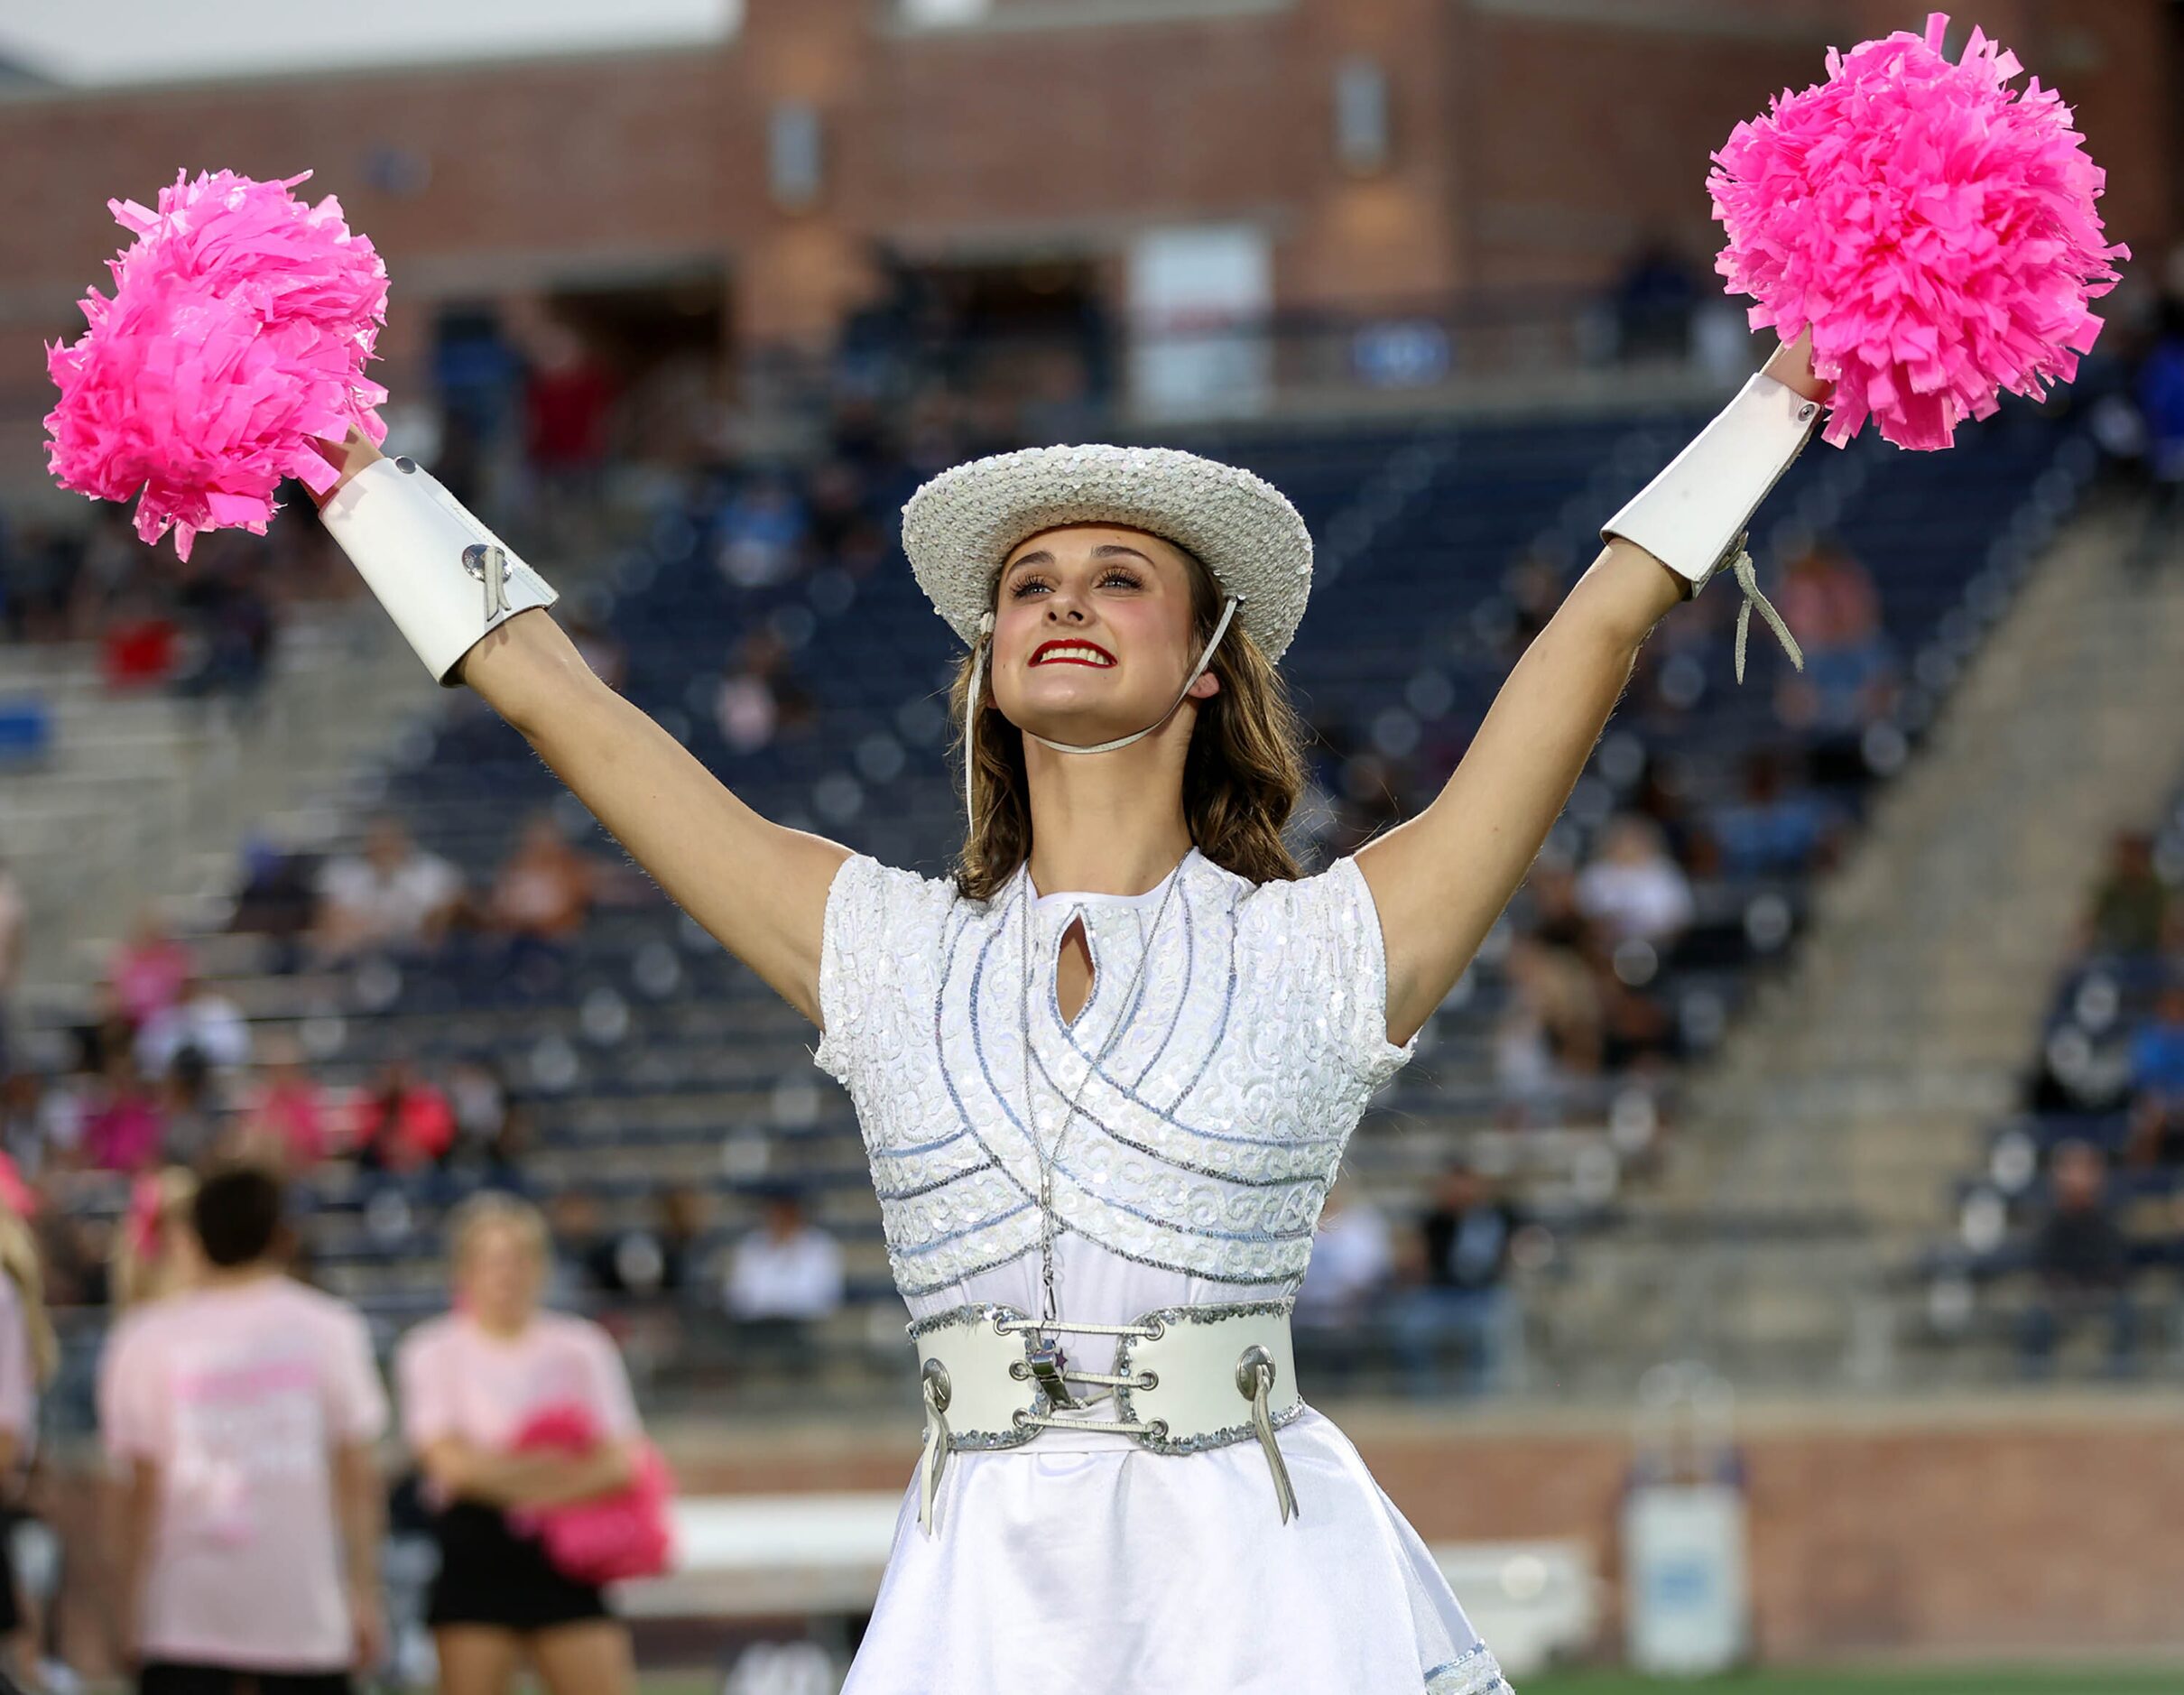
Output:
top-left (305, 431), bottom-right (849, 1023)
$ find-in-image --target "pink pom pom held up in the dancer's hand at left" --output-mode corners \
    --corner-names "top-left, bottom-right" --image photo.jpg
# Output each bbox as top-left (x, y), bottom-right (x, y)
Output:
top-left (46, 171), bottom-right (386, 560)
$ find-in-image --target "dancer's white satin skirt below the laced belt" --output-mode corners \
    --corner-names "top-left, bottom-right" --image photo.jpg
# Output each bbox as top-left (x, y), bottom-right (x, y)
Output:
top-left (843, 1407), bottom-right (1509, 1695)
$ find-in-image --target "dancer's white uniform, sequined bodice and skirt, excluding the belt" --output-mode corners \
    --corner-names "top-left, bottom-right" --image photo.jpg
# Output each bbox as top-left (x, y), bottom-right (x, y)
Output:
top-left (812, 849), bottom-right (1507, 1695)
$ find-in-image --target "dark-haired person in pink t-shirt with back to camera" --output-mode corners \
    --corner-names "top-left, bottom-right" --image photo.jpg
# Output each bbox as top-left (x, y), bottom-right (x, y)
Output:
top-left (98, 1164), bottom-right (386, 1695)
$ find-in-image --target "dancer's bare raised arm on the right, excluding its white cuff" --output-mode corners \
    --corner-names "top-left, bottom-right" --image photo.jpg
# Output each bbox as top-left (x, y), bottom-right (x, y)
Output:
top-left (1358, 332), bottom-right (1828, 1044)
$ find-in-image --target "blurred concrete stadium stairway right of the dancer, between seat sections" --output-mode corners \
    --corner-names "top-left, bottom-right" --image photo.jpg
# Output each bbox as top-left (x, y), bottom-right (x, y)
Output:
top-left (1555, 503), bottom-right (2184, 1383)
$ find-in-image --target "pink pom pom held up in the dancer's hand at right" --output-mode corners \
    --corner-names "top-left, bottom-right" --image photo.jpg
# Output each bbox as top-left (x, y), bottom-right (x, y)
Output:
top-left (1706, 11), bottom-right (2130, 448)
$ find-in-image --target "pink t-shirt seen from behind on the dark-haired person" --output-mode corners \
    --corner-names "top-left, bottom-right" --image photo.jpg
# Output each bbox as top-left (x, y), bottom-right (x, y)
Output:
top-left (98, 1278), bottom-right (386, 1671)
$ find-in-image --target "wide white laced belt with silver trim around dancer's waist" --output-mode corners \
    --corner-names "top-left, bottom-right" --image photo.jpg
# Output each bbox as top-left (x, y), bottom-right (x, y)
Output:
top-left (906, 1300), bottom-right (1304, 1535)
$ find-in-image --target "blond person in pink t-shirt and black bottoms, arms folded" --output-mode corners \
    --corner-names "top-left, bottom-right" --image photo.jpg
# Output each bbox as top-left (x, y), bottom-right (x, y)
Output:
top-left (395, 1190), bottom-right (642, 1695)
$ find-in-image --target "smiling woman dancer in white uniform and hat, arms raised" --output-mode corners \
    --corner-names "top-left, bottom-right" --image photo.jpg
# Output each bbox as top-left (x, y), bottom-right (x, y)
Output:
top-left (308, 325), bottom-right (1824, 1695)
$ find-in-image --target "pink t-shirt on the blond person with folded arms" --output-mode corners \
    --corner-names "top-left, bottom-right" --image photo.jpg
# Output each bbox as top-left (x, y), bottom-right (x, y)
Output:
top-left (395, 1312), bottom-right (640, 1452)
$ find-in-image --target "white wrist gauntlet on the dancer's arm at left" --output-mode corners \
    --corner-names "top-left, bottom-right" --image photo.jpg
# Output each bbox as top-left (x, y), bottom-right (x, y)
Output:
top-left (319, 458), bottom-right (561, 688)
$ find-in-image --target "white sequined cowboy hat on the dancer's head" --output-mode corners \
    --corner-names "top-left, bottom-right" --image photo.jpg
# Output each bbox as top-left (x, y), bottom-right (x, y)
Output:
top-left (902, 443), bottom-right (1312, 660)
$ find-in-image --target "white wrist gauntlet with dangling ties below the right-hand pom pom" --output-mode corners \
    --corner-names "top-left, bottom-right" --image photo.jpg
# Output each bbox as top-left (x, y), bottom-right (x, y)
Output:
top-left (1601, 371), bottom-right (1819, 681)
